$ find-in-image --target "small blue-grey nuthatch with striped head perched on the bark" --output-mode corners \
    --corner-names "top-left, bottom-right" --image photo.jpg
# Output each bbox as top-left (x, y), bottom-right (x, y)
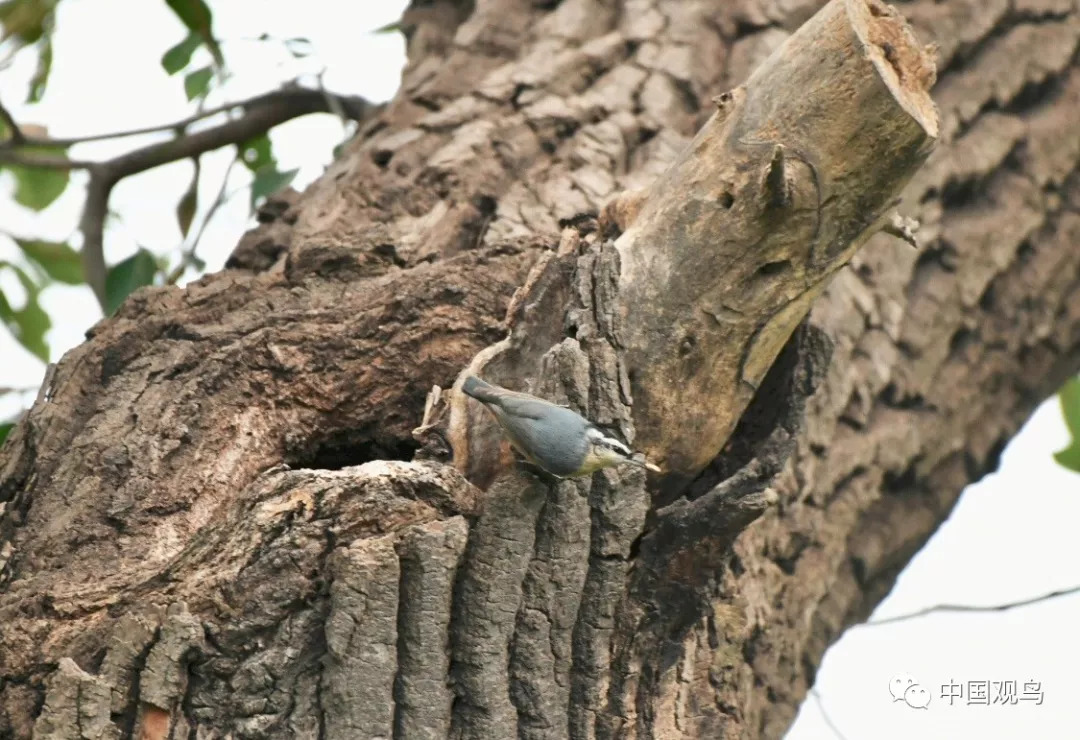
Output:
top-left (461, 375), bottom-right (660, 477)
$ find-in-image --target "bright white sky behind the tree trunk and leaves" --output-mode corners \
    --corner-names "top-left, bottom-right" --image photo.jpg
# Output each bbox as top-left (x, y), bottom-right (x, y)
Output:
top-left (0, 0), bottom-right (1080, 740)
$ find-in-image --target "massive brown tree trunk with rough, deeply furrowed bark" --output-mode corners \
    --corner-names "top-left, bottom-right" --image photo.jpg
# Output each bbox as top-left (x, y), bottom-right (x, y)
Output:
top-left (0, 0), bottom-right (1080, 738)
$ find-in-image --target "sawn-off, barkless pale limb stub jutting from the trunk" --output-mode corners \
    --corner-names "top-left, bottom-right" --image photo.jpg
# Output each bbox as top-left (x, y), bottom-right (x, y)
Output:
top-left (616, 0), bottom-right (937, 480)
